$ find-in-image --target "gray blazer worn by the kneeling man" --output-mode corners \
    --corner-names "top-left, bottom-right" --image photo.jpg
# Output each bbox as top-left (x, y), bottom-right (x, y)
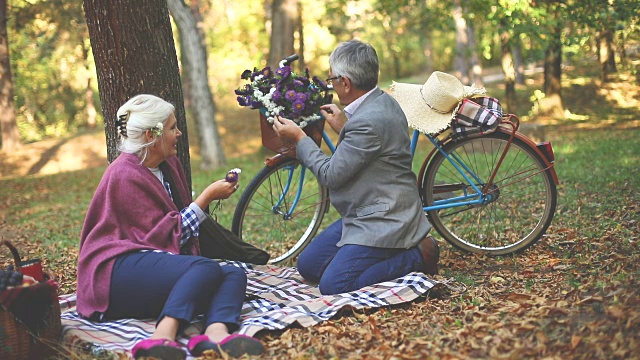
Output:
top-left (296, 88), bottom-right (431, 248)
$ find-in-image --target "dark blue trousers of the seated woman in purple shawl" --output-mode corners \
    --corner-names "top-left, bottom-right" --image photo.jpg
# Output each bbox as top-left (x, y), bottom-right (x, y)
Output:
top-left (105, 252), bottom-right (247, 332)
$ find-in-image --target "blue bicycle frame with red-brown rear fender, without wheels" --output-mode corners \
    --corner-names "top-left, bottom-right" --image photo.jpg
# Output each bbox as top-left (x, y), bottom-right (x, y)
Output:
top-left (265, 114), bottom-right (559, 218)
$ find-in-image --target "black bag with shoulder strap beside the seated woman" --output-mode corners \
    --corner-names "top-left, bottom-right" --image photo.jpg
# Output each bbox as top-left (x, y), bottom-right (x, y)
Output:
top-left (160, 163), bottom-right (269, 265)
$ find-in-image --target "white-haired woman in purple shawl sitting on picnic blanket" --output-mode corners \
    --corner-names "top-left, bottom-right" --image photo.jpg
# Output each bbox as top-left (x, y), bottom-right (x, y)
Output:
top-left (77, 95), bottom-right (263, 359)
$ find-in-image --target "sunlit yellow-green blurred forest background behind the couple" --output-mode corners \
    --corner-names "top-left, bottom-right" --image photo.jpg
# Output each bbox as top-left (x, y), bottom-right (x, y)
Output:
top-left (0, 0), bottom-right (640, 170)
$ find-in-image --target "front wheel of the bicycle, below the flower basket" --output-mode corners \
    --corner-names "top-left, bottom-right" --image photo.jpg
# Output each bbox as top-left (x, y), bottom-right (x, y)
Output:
top-left (232, 159), bottom-right (330, 264)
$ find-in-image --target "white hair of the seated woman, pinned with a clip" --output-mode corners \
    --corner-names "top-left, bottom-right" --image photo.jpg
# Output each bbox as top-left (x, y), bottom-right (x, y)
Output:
top-left (116, 94), bottom-right (175, 159)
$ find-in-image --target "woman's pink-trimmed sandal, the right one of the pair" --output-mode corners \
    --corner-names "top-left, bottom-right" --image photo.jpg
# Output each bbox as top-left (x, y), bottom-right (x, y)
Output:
top-left (187, 334), bottom-right (264, 358)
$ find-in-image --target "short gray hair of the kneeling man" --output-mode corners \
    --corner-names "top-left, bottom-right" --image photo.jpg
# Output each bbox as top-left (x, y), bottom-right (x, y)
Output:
top-left (329, 40), bottom-right (380, 91)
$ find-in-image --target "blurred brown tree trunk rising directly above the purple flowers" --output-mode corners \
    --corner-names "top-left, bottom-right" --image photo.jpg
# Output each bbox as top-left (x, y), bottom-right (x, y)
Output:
top-left (268, 0), bottom-right (299, 67)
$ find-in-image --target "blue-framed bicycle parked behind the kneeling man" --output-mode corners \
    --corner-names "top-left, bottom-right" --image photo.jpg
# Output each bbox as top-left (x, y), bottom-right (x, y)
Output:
top-left (232, 67), bottom-right (559, 264)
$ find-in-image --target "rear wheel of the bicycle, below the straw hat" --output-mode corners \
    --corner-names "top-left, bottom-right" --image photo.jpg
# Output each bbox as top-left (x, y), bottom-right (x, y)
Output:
top-left (421, 131), bottom-right (558, 255)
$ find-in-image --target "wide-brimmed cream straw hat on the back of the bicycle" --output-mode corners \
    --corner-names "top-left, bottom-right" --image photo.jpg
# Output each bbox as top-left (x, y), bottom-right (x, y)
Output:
top-left (391, 71), bottom-right (486, 134)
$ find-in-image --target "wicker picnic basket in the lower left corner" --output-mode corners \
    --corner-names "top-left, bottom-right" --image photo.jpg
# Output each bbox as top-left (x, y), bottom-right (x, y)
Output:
top-left (0, 241), bottom-right (62, 360)
